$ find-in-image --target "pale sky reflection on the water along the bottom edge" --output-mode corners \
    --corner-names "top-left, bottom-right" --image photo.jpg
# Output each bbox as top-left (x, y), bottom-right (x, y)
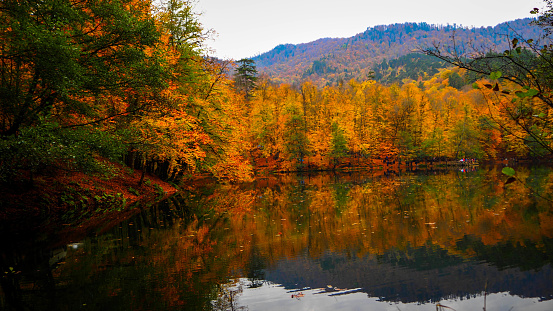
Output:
top-left (238, 280), bottom-right (553, 311)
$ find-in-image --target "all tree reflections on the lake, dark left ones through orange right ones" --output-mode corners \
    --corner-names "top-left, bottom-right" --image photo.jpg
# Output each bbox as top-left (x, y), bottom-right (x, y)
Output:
top-left (41, 168), bottom-right (553, 310)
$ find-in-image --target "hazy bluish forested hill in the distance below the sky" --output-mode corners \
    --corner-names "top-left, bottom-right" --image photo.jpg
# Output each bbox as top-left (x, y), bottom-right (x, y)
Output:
top-left (253, 18), bottom-right (543, 86)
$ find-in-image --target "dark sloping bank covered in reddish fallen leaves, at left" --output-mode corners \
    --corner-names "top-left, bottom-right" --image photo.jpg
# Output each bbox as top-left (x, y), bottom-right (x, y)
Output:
top-left (0, 164), bottom-right (177, 241)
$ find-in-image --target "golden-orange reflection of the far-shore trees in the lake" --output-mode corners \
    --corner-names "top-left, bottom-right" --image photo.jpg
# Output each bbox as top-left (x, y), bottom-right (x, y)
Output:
top-left (193, 169), bottom-right (553, 262)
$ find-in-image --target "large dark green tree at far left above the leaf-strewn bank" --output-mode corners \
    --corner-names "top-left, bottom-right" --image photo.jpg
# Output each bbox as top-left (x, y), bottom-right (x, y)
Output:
top-left (0, 0), bottom-right (167, 181)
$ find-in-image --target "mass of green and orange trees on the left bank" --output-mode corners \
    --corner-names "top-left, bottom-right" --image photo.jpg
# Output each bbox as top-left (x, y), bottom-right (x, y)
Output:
top-left (0, 0), bottom-right (254, 182)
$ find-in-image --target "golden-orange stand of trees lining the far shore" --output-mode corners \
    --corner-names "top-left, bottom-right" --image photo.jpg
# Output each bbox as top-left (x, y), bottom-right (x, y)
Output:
top-left (249, 70), bottom-right (551, 173)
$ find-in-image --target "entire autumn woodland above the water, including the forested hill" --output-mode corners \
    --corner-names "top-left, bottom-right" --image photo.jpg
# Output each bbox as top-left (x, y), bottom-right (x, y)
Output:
top-left (0, 0), bottom-right (553, 191)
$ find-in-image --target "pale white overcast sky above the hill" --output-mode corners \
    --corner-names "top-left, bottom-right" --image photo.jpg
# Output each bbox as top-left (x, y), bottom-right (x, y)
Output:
top-left (195, 0), bottom-right (544, 60)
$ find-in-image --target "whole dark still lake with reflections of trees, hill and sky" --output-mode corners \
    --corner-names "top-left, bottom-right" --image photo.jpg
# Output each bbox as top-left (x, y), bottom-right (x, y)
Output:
top-left (0, 168), bottom-right (553, 311)
